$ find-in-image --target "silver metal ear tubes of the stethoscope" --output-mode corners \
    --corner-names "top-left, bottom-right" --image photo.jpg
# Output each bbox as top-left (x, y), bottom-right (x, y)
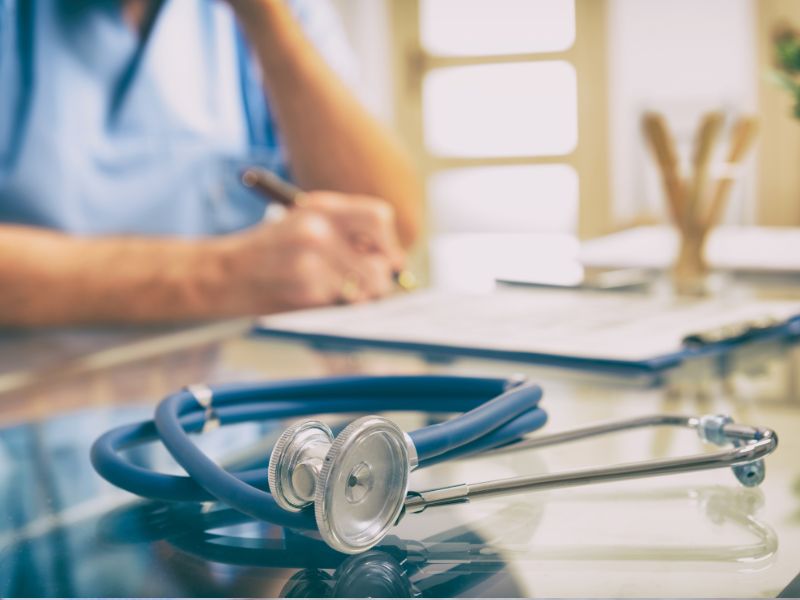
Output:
top-left (404, 415), bottom-right (778, 513)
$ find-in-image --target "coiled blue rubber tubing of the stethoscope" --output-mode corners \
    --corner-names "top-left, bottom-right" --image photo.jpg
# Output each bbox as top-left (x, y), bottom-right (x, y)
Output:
top-left (91, 376), bottom-right (546, 529)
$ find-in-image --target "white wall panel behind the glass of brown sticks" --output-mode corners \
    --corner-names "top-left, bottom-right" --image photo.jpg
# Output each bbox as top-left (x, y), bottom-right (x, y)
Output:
top-left (609, 0), bottom-right (758, 223)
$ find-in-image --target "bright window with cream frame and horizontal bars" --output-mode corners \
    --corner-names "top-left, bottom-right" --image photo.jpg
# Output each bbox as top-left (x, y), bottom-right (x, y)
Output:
top-left (393, 0), bottom-right (607, 289)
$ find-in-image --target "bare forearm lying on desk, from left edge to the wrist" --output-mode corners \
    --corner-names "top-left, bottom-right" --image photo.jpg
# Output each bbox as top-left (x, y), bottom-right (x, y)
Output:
top-left (0, 225), bottom-right (225, 326)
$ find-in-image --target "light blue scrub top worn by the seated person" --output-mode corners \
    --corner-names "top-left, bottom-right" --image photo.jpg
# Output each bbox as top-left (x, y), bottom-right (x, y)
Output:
top-left (0, 0), bottom-right (354, 237)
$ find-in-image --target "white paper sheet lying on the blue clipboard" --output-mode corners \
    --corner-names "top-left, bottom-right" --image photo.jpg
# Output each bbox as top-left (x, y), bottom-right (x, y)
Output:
top-left (260, 289), bottom-right (800, 362)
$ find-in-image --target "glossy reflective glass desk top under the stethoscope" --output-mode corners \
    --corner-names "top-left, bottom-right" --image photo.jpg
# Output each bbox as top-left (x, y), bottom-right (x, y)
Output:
top-left (0, 321), bottom-right (800, 597)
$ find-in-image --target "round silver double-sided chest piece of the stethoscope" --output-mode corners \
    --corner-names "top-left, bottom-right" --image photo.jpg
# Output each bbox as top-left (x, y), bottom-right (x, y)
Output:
top-left (269, 416), bottom-right (416, 554)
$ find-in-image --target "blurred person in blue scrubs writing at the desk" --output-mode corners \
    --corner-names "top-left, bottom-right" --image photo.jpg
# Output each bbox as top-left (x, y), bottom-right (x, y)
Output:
top-left (0, 0), bottom-right (419, 326)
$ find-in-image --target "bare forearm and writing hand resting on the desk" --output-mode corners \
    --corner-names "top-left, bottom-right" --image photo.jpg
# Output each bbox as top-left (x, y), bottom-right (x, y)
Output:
top-left (0, 192), bottom-right (402, 327)
